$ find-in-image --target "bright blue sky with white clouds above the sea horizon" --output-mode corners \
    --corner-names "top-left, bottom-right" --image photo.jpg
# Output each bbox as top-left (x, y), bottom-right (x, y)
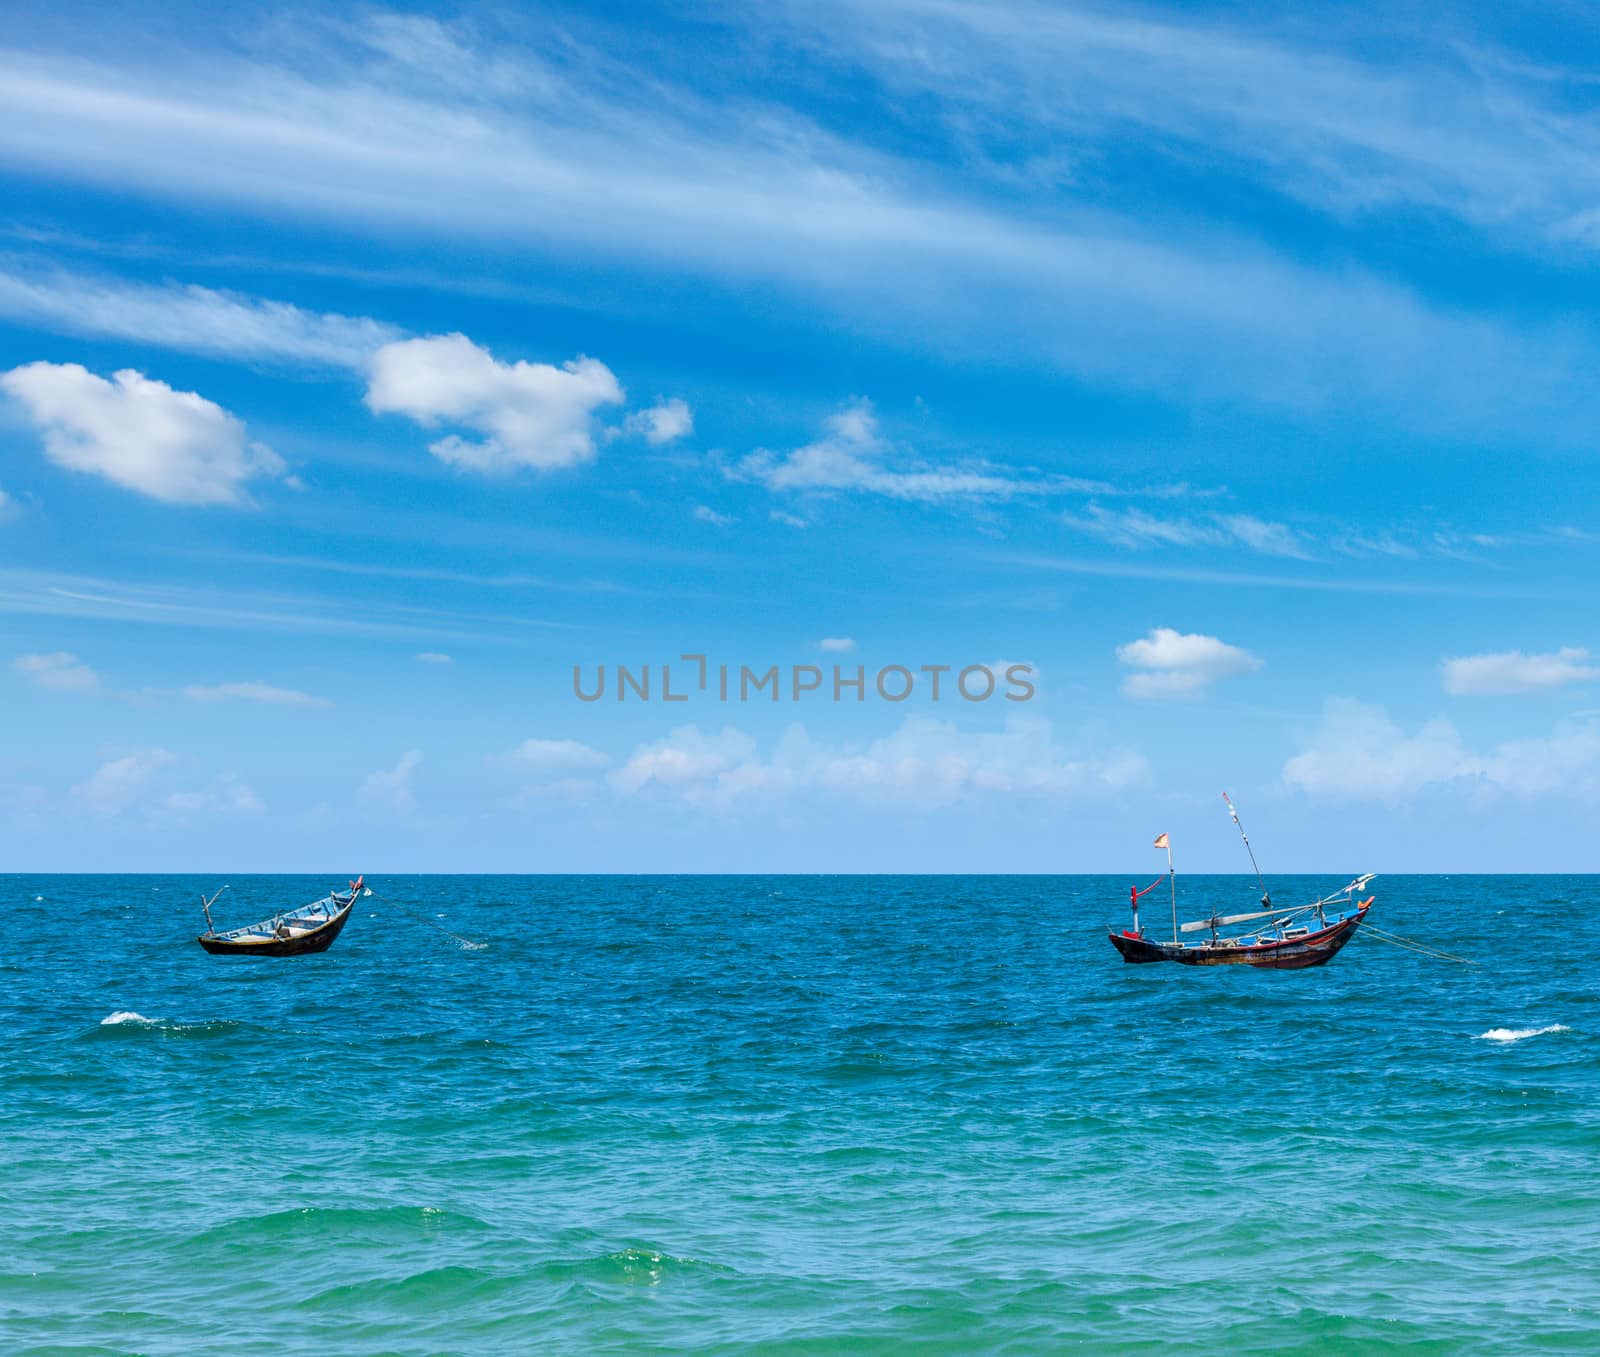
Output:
top-left (0, 0), bottom-right (1600, 885)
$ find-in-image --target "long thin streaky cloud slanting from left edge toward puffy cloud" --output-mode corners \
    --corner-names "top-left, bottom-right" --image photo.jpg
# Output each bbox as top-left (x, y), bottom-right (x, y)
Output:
top-left (0, 269), bottom-right (400, 371)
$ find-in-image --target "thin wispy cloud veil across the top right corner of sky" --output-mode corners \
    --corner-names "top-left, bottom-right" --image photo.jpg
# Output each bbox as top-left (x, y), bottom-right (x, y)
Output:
top-left (790, 0), bottom-right (1600, 257)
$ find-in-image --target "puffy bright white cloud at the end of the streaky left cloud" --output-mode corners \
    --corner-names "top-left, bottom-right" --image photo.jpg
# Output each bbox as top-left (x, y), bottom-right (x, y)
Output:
top-left (366, 334), bottom-right (624, 474)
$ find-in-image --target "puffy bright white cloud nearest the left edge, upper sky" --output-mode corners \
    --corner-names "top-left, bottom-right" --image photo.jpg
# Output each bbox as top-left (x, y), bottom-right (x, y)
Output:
top-left (0, 363), bottom-right (283, 504)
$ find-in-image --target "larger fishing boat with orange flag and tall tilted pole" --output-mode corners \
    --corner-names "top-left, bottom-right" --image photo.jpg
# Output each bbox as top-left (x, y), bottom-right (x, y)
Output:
top-left (1107, 792), bottom-right (1376, 971)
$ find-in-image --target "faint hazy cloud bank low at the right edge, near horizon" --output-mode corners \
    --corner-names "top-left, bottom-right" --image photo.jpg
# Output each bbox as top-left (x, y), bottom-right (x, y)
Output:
top-left (1283, 698), bottom-right (1600, 805)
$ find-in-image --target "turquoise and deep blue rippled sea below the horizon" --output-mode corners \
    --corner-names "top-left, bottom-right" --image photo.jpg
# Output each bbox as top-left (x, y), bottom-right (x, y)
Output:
top-left (0, 875), bottom-right (1600, 1354)
